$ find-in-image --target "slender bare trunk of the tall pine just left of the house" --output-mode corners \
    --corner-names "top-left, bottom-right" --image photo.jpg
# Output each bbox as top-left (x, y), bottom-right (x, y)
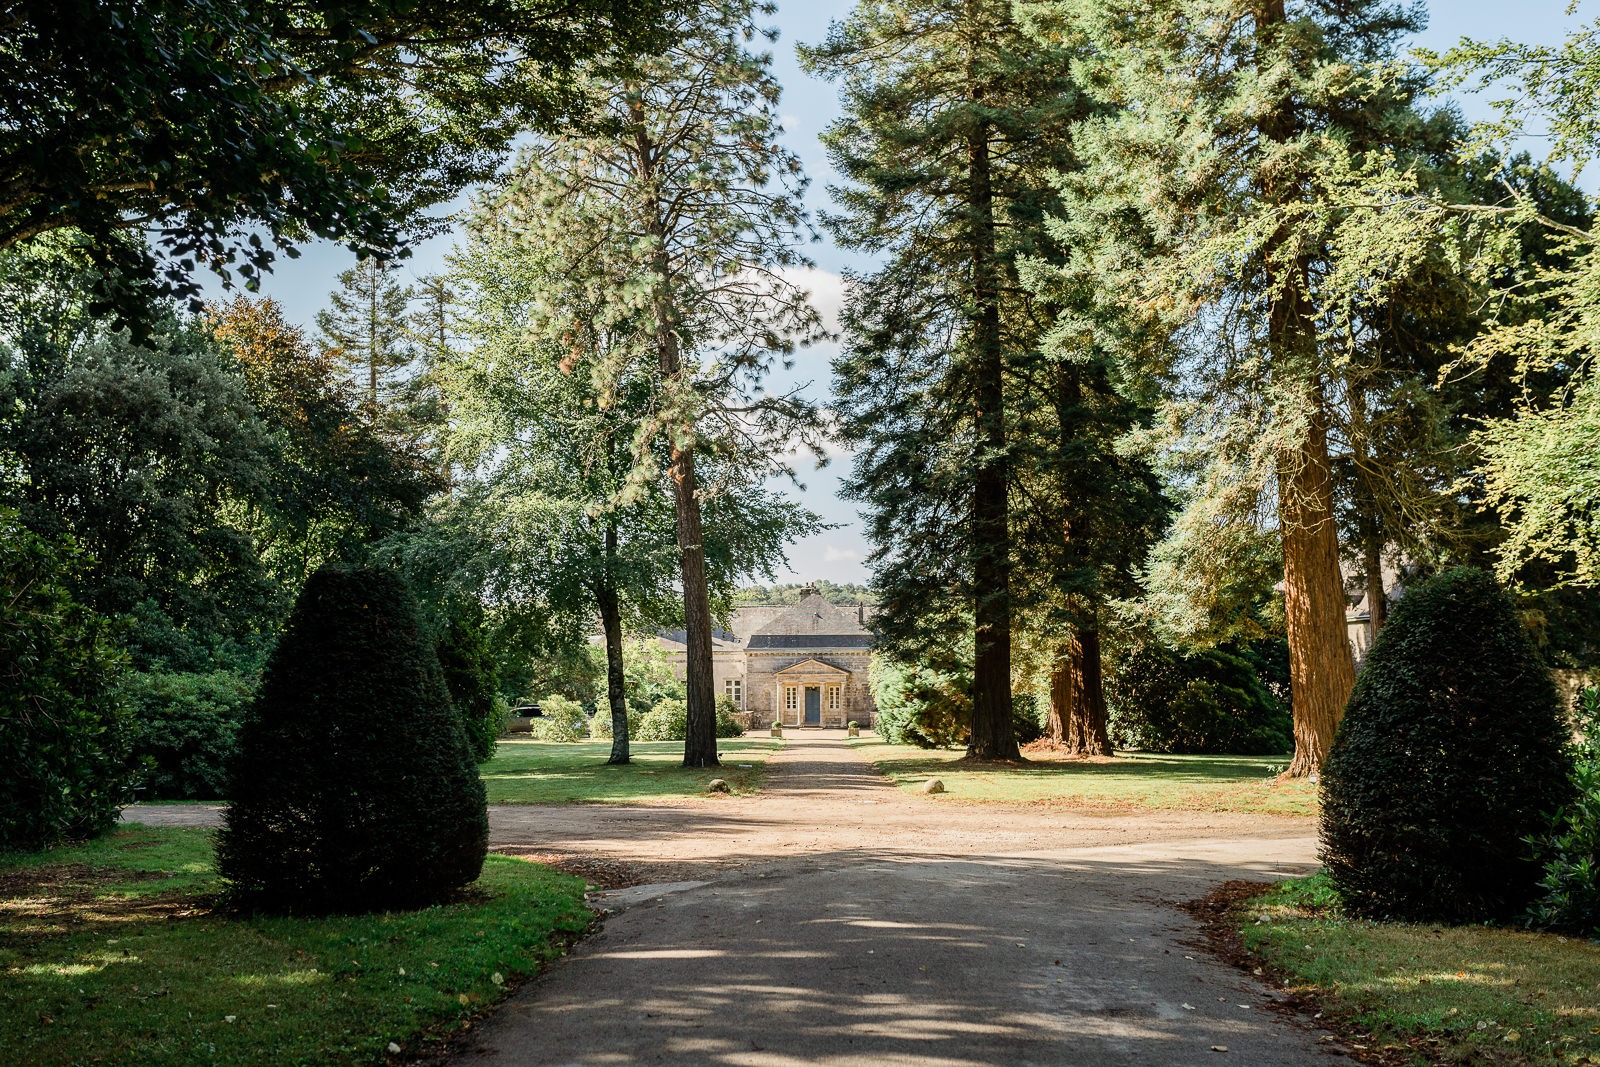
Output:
top-left (632, 101), bottom-right (718, 766)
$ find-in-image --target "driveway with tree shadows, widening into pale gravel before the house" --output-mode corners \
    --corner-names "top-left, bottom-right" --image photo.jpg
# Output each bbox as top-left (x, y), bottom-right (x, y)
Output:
top-left (128, 733), bottom-right (1336, 1067)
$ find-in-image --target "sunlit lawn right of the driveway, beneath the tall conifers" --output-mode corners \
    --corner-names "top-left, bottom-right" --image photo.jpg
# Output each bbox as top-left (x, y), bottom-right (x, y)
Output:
top-left (853, 737), bottom-right (1317, 816)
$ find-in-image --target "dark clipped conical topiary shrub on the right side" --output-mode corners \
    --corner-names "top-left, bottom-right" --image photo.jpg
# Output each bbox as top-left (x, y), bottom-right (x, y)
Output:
top-left (1322, 568), bottom-right (1570, 923)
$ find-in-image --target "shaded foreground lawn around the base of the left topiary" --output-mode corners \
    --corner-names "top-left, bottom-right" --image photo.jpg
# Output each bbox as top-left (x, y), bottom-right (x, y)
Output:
top-left (0, 827), bottom-right (590, 1067)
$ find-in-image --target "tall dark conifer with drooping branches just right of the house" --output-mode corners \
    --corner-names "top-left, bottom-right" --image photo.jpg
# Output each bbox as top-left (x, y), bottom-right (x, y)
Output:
top-left (802, 0), bottom-right (1078, 760)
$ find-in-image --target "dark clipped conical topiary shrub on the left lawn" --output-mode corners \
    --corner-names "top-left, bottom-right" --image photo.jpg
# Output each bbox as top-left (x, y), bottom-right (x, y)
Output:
top-left (218, 569), bottom-right (488, 912)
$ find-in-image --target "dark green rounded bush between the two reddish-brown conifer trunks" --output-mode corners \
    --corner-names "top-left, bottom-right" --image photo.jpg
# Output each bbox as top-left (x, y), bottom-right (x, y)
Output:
top-left (1106, 630), bottom-right (1294, 755)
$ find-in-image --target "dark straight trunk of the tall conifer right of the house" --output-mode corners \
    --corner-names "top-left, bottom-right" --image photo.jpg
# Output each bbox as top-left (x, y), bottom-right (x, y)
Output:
top-left (966, 116), bottom-right (1021, 760)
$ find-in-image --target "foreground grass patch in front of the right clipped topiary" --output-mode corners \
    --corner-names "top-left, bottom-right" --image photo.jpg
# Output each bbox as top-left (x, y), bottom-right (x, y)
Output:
top-left (1235, 873), bottom-right (1600, 1064)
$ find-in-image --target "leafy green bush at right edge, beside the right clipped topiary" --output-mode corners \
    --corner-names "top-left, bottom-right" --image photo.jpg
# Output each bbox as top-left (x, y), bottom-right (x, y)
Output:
top-left (1528, 689), bottom-right (1600, 941)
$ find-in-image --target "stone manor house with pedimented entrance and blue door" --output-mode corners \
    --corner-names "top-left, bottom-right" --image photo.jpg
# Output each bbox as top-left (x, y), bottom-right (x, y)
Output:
top-left (661, 585), bottom-right (877, 728)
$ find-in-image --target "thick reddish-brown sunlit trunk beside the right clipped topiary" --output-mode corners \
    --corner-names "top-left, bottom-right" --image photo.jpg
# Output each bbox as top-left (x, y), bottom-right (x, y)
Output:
top-left (1278, 398), bottom-right (1355, 777)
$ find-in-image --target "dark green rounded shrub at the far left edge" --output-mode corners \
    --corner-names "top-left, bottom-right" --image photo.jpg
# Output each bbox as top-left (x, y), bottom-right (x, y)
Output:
top-left (0, 509), bottom-right (134, 853)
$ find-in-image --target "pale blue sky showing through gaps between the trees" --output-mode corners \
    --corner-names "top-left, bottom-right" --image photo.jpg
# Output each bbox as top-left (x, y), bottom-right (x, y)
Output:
top-left (212, 0), bottom-right (1597, 582)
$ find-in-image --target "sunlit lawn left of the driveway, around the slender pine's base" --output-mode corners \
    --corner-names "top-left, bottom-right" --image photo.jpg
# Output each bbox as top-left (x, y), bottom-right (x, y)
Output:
top-left (483, 737), bottom-right (782, 805)
